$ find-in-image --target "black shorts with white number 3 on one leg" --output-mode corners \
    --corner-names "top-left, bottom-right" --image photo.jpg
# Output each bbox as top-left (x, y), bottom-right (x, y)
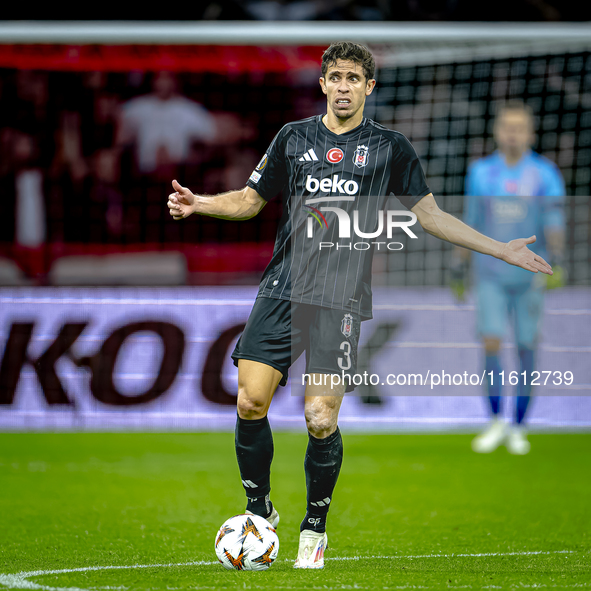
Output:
top-left (232, 297), bottom-right (361, 392)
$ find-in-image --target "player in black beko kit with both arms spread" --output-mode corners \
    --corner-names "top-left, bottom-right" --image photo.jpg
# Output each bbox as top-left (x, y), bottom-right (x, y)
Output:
top-left (168, 42), bottom-right (552, 568)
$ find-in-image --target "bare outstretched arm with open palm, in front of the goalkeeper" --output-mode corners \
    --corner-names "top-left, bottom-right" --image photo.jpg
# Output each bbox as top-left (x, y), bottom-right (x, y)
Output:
top-left (411, 194), bottom-right (552, 275)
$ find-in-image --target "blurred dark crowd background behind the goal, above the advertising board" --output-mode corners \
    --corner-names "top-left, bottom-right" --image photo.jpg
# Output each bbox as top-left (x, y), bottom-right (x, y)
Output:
top-left (0, 13), bottom-right (591, 285)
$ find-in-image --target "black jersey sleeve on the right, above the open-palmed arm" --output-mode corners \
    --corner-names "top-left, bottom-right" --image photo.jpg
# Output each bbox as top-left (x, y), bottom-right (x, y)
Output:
top-left (390, 134), bottom-right (431, 209)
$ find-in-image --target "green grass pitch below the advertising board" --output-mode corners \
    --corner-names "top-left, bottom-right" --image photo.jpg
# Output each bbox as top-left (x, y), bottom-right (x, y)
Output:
top-left (0, 430), bottom-right (591, 591)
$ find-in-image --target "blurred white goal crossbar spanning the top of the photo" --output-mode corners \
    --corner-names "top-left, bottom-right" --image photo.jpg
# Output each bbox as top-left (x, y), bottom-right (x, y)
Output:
top-left (0, 21), bottom-right (591, 67)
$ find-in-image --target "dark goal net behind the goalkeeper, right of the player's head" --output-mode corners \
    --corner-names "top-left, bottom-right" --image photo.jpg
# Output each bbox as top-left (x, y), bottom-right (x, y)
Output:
top-left (374, 35), bottom-right (591, 285)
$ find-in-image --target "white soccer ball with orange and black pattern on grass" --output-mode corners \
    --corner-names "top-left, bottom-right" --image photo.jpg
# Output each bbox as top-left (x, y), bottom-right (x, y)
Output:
top-left (215, 515), bottom-right (279, 570)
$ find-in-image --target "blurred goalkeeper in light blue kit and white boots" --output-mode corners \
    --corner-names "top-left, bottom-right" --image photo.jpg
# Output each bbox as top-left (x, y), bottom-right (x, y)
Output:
top-left (451, 101), bottom-right (566, 455)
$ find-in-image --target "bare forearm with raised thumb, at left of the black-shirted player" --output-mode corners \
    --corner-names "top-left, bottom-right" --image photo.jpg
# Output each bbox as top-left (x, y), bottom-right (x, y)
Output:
top-left (167, 181), bottom-right (266, 220)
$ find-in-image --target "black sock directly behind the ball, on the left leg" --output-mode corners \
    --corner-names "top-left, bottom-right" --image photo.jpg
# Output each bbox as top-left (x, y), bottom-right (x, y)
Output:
top-left (235, 417), bottom-right (273, 517)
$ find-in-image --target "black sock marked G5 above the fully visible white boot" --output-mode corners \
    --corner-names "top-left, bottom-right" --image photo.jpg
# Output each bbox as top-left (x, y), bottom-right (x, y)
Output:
top-left (300, 427), bottom-right (343, 532)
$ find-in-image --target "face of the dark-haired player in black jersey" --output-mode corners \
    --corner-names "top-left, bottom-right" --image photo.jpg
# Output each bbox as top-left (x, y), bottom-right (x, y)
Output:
top-left (320, 60), bottom-right (376, 119)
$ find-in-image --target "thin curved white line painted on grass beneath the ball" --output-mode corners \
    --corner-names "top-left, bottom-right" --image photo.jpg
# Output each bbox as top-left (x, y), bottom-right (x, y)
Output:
top-left (0, 550), bottom-right (576, 591)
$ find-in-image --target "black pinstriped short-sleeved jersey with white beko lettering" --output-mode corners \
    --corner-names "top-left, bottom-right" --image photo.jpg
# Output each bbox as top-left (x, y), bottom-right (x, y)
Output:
top-left (247, 115), bottom-right (430, 318)
